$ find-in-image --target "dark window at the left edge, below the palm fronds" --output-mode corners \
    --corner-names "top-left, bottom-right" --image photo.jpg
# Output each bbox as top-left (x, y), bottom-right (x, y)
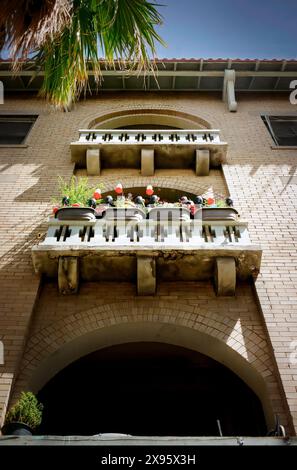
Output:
top-left (0, 114), bottom-right (37, 145)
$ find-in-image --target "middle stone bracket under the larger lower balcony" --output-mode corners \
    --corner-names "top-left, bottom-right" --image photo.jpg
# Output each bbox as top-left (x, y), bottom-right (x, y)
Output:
top-left (137, 256), bottom-right (156, 295)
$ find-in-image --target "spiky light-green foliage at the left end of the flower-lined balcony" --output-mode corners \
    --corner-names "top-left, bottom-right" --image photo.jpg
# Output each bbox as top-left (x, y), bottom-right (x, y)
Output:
top-left (52, 176), bottom-right (104, 206)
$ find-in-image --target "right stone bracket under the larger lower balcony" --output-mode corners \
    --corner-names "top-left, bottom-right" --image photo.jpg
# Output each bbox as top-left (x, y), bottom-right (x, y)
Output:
top-left (214, 257), bottom-right (236, 296)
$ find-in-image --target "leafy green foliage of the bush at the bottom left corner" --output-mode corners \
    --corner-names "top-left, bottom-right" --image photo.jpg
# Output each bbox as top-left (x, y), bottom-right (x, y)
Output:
top-left (5, 392), bottom-right (43, 429)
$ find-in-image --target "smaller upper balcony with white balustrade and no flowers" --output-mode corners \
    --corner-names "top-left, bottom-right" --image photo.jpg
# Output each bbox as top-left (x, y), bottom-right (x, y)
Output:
top-left (70, 129), bottom-right (227, 176)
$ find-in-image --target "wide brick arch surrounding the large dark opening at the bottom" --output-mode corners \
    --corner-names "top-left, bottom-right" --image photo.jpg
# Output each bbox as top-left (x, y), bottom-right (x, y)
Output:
top-left (15, 302), bottom-right (279, 427)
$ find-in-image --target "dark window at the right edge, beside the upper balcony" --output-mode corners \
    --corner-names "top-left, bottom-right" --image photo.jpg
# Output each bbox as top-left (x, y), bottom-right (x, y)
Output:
top-left (262, 116), bottom-right (297, 146)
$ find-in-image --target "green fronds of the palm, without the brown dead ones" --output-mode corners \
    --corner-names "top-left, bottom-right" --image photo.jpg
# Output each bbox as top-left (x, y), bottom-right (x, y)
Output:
top-left (35, 0), bottom-right (164, 109)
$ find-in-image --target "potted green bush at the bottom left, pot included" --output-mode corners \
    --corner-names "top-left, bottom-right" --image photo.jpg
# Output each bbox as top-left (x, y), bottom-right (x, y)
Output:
top-left (2, 392), bottom-right (43, 436)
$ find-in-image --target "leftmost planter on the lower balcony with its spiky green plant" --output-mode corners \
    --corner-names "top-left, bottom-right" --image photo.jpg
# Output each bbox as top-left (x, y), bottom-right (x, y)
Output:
top-left (52, 176), bottom-right (103, 220)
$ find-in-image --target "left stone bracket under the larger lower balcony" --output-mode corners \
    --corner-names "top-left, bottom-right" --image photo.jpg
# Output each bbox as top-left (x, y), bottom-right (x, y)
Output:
top-left (58, 256), bottom-right (79, 294)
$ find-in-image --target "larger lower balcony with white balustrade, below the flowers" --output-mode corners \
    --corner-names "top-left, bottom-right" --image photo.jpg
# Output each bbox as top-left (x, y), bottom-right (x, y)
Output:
top-left (32, 207), bottom-right (261, 295)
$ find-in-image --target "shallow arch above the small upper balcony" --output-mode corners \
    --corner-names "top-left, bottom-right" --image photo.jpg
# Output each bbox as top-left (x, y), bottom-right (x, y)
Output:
top-left (81, 103), bottom-right (212, 129)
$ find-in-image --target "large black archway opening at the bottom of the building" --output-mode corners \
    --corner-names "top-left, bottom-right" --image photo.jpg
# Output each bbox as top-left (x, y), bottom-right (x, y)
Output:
top-left (38, 342), bottom-right (266, 436)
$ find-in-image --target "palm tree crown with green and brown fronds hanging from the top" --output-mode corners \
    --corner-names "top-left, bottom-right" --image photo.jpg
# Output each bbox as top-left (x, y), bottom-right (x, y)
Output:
top-left (0, 0), bottom-right (164, 109)
